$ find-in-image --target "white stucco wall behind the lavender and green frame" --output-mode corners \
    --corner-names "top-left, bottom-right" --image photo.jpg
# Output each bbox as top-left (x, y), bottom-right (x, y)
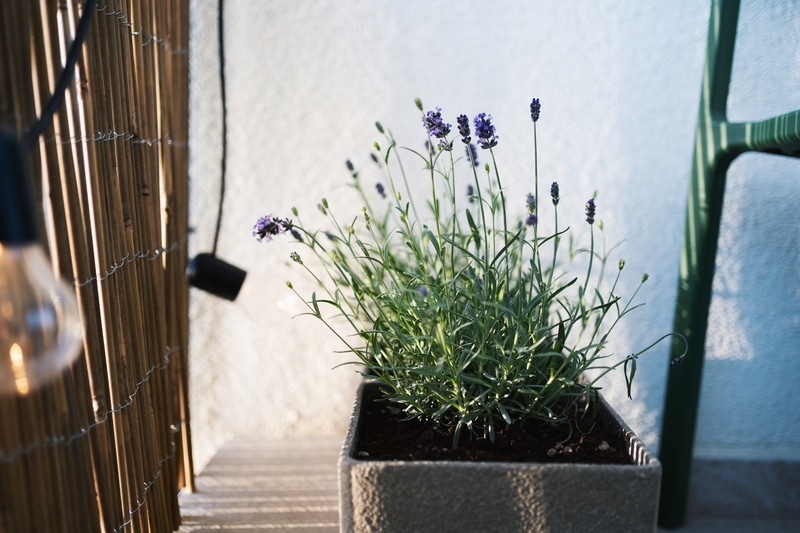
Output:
top-left (190, 0), bottom-right (800, 467)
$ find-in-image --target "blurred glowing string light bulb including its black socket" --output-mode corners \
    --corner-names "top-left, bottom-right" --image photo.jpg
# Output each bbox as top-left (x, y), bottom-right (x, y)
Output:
top-left (0, 130), bottom-right (83, 395)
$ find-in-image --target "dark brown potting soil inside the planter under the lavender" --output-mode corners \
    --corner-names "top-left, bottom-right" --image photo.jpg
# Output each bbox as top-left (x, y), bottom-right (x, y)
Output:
top-left (356, 387), bottom-right (632, 464)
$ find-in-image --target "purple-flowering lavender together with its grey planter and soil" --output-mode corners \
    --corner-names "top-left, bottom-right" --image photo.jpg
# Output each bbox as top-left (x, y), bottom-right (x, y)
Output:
top-left (253, 99), bottom-right (680, 532)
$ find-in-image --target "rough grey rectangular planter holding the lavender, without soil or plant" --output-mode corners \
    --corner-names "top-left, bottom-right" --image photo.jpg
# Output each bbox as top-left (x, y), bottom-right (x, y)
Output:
top-left (339, 383), bottom-right (661, 533)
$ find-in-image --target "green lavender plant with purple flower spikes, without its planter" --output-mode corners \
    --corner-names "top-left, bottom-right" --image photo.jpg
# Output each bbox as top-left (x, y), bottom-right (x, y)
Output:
top-left (253, 99), bottom-right (680, 446)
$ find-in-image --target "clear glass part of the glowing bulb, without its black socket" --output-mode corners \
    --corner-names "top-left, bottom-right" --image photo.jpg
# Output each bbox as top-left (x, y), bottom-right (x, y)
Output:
top-left (0, 243), bottom-right (83, 395)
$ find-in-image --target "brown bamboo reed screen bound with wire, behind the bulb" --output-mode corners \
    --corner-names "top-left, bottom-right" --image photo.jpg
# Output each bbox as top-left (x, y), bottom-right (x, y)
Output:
top-left (0, 0), bottom-right (193, 533)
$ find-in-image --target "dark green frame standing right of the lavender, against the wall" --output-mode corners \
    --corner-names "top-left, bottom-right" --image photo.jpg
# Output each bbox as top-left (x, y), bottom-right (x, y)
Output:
top-left (659, 0), bottom-right (800, 528)
